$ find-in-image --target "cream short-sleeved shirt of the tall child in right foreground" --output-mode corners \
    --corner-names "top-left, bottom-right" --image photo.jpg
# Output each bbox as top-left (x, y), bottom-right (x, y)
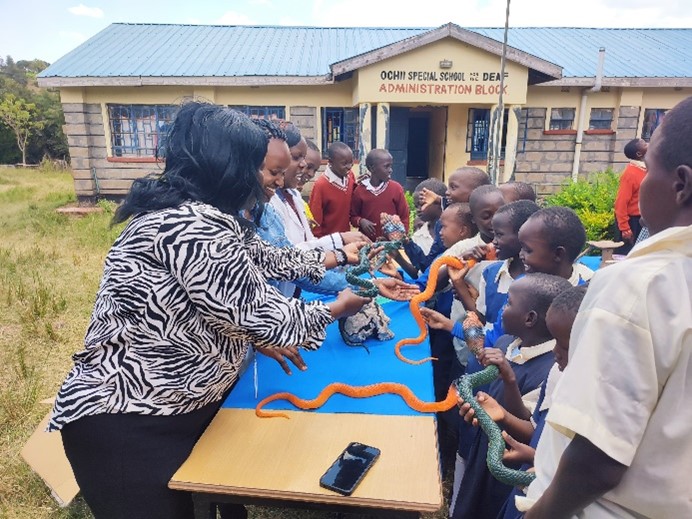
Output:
top-left (517, 226), bottom-right (692, 518)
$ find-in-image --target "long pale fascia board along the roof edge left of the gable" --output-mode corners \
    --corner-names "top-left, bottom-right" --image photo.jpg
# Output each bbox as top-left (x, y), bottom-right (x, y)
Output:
top-left (38, 75), bottom-right (334, 88)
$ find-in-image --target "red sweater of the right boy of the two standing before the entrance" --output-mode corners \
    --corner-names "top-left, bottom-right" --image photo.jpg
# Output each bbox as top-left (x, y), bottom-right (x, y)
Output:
top-left (351, 180), bottom-right (409, 238)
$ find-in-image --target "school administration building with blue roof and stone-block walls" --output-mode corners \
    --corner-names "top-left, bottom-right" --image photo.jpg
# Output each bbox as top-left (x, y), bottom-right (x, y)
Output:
top-left (39, 23), bottom-right (692, 199)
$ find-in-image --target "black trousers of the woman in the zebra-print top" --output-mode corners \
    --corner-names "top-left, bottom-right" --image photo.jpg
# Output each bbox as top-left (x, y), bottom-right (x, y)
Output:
top-left (61, 402), bottom-right (247, 519)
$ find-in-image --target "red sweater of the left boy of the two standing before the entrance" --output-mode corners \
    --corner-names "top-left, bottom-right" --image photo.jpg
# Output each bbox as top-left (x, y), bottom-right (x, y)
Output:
top-left (310, 171), bottom-right (356, 238)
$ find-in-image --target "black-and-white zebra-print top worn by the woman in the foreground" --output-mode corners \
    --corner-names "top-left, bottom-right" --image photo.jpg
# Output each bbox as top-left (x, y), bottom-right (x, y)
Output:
top-left (48, 202), bottom-right (332, 430)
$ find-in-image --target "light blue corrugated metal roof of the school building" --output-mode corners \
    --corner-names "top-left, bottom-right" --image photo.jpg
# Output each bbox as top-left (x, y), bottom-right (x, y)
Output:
top-left (39, 24), bottom-right (692, 78)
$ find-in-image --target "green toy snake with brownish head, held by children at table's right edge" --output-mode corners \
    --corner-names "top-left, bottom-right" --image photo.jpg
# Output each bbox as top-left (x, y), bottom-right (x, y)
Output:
top-left (454, 313), bottom-right (536, 492)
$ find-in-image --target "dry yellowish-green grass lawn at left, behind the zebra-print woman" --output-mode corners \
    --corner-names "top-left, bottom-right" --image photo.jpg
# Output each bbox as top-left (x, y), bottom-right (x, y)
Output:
top-left (0, 168), bottom-right (446, 519)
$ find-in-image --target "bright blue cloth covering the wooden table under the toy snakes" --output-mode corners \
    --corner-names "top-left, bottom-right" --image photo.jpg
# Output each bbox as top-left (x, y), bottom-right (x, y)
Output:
top-left (222, 294), bottom-right (435, 415)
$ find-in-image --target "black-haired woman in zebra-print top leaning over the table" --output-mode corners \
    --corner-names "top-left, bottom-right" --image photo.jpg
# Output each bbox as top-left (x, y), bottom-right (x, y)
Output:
top-left (49, 103), bottom-right (374, 519)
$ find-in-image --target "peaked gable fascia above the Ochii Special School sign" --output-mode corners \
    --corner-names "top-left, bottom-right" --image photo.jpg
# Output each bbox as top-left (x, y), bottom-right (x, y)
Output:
top-left (330, 23), bottom-right (562, 78)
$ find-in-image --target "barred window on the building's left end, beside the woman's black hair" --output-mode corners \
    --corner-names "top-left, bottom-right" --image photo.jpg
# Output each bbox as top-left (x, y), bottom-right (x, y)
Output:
top-left (108, 105), bottom-right (178, 157)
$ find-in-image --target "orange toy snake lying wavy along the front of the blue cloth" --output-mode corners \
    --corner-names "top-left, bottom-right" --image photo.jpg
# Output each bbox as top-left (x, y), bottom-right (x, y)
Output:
top-left (255, 382), bottom-right (458, 418)
